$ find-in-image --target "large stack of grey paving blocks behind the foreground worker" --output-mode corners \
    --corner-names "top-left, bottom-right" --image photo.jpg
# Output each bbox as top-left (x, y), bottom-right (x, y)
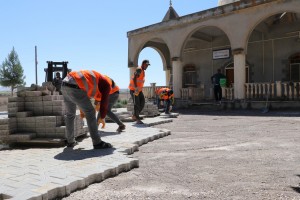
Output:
top-left (0, 83), bottom-right (87, 143)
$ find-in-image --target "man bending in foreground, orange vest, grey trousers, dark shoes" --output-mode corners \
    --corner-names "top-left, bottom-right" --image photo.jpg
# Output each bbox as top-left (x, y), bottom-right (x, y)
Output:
top-left (61, 70), bottom-right (112, 149)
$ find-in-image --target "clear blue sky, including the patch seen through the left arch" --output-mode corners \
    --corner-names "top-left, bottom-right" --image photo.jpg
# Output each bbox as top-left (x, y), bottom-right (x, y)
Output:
top-left (0, 0), bottom-right (218, 88)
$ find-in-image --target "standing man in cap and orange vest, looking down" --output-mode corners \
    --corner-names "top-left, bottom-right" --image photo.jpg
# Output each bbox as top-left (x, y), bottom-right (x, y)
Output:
top-left (128, 60), bottom-right (150, 124)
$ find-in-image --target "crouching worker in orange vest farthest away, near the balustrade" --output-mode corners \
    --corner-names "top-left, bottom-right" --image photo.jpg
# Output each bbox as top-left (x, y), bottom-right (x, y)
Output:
top-left (156, 88), bottom-right (174, 114)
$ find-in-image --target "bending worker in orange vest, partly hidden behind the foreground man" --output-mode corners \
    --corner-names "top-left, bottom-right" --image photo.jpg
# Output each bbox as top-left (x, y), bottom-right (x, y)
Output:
top-left (96, 75), bottom-right (125, 132)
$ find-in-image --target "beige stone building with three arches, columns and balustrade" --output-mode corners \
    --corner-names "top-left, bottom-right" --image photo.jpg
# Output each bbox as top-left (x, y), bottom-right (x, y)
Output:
top-left (127, 0), bottom-right (300, 101)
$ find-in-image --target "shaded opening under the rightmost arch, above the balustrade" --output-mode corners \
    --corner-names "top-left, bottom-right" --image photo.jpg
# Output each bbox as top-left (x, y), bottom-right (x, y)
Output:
top-left (246, 8), bottom-right (300, 82)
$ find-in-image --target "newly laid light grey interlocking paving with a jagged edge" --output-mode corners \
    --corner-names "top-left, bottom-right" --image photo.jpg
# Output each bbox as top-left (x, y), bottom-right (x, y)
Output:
top-left (0, 116), bottom-right (172, 200)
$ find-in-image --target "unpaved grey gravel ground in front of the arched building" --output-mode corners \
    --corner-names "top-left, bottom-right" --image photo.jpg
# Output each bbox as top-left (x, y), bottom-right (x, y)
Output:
top-left (64, 110), bottom-right (300, 200)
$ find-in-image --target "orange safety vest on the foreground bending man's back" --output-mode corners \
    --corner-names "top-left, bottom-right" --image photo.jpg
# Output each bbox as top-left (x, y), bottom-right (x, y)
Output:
top-left (68, 70), bottom-right (103, 101)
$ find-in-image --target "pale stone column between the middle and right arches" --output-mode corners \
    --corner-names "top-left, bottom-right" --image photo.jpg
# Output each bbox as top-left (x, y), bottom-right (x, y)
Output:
top-left (233, 49), bottom-right (246, 99)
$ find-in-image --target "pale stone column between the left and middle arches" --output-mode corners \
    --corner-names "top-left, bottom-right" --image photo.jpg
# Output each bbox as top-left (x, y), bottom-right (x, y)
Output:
top-left (172, 57), bottom-right (182, 98)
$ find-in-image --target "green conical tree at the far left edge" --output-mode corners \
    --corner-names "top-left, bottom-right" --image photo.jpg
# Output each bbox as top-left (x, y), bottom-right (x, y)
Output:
top-left (0, 47), bottom-right (26, 96)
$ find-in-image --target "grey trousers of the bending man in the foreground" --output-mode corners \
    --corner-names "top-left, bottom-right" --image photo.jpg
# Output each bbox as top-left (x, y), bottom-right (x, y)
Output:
top-left (61, 86), bottom-right (101, 145)
